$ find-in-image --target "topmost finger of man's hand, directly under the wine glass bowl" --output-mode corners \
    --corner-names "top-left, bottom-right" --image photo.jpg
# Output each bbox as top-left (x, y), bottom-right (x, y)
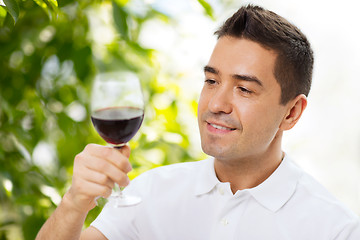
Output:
top-left (85, 144), bottom-right (132, 173)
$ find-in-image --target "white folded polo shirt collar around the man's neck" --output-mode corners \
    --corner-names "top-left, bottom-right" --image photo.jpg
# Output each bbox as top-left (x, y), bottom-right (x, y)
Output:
top-left (195, 154), bottom-right (302, 212)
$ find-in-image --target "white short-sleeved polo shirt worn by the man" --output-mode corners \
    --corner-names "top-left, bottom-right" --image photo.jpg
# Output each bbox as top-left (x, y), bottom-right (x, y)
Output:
top-left (92, 156), bottom-right (360, 240)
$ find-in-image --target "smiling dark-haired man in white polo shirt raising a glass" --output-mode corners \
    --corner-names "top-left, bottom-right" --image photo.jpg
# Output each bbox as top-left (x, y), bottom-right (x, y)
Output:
top-left (37, 5), bottom-right (360, 240)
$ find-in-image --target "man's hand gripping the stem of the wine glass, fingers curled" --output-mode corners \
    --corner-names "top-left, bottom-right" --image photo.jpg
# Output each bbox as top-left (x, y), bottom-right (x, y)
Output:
top-left (64, 144), bottom-right (132, 213)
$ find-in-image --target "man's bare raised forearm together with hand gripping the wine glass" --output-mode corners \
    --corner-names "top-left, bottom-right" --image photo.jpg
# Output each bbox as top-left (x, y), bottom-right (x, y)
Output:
top-left (36, 144), bottom-right (131, 240)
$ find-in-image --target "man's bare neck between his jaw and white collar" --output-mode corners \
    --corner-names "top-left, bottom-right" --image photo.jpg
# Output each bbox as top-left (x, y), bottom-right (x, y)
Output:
top-left (214, 134), bottom-right (284, 193)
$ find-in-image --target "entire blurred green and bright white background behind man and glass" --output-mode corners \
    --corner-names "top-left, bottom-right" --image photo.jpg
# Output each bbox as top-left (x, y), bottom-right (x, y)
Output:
top-left (0, 0), bottom-right (360, 240)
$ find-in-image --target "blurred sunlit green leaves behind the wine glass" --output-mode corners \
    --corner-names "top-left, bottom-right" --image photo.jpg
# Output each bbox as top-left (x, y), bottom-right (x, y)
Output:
top-left (0, 0), bottom-right (214, 240)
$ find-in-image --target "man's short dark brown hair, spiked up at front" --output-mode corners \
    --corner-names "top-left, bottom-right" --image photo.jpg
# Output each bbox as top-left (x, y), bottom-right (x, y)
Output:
top-left (215, 5), bottom-right (314, 104)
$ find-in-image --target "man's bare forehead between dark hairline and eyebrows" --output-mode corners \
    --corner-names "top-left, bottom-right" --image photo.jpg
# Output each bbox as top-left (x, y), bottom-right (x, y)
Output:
top-left (208, 36), bottom-right (277, 87)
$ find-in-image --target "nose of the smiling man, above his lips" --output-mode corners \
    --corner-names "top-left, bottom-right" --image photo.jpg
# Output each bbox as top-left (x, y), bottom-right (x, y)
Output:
top-left (208, 85), bottom-right (233, 114)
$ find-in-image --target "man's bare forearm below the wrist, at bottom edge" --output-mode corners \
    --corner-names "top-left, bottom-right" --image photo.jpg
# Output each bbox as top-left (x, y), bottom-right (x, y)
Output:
top-left (36, 191), bottom-right (87, 240)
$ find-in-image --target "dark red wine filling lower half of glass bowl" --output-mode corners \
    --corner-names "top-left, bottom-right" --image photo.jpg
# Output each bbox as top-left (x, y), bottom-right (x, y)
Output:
top-left (91, 107), bottom-right (144, 145)
